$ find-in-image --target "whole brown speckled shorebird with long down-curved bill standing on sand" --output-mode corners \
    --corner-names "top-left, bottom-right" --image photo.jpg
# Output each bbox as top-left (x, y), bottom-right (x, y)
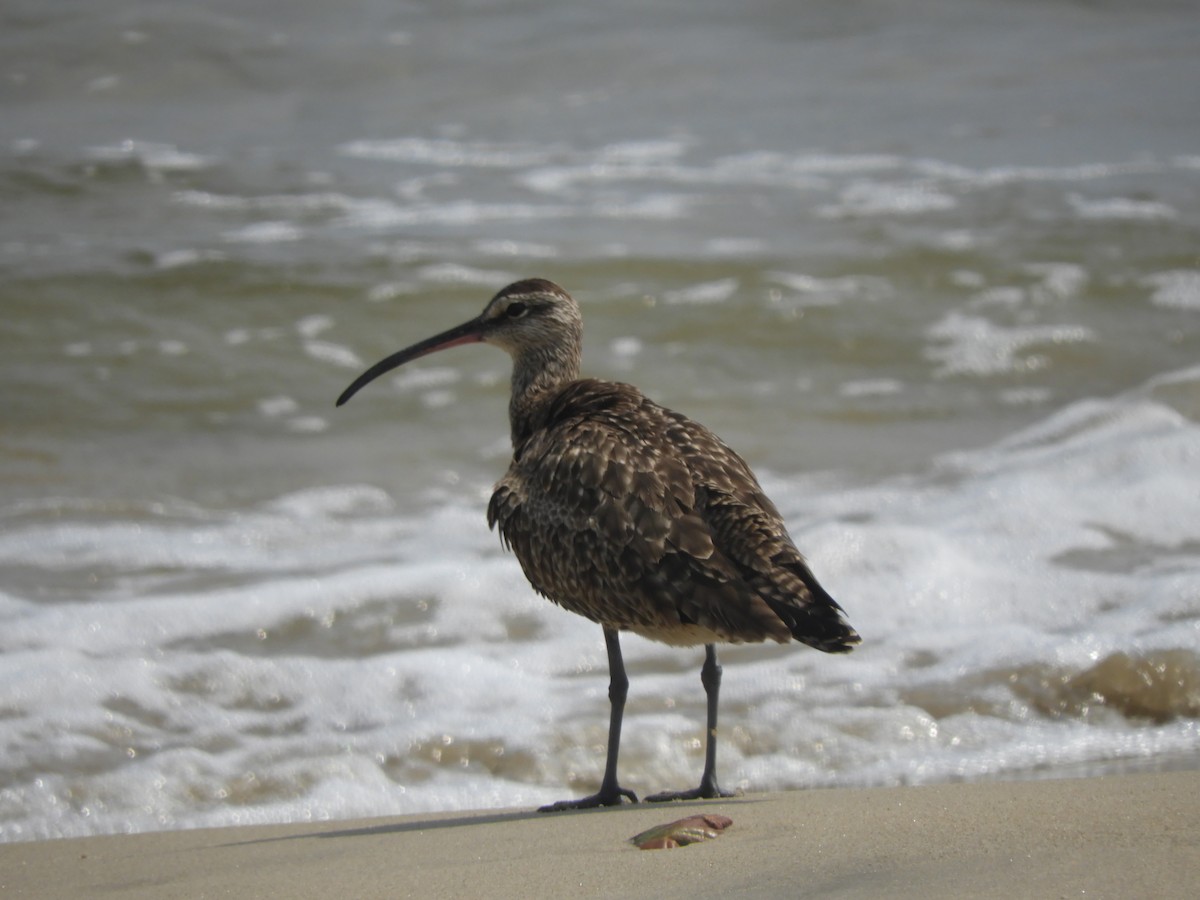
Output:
top-left (337, 278), bottom-right (859, 812)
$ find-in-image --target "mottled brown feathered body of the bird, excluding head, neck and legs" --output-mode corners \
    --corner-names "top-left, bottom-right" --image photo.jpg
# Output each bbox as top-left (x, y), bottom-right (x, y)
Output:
top-left (488, 380), bottom-right (857, 650)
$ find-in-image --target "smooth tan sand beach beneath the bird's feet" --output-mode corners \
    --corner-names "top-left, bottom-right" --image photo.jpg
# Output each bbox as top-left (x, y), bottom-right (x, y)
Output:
top-left (0, 772), bottom-right (1200, 900)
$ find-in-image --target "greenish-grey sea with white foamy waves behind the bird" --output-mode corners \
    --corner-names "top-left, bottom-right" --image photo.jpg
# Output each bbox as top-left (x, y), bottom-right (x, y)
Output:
top-left (0, 0), bottom-right (1200, 841)
